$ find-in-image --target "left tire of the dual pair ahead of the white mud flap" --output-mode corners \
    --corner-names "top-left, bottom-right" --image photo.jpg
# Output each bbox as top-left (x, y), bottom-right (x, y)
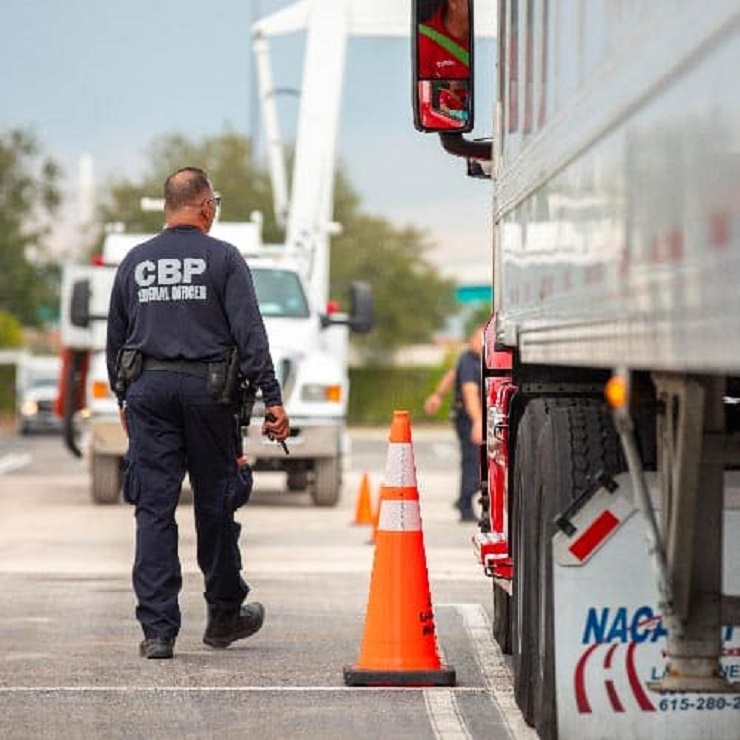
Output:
top-left (510, 399), bottom-right (548, 725)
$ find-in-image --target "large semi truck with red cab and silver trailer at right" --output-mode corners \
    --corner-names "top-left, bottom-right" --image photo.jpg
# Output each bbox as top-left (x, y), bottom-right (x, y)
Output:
top-left (411, 0), bottom-right (740, 740)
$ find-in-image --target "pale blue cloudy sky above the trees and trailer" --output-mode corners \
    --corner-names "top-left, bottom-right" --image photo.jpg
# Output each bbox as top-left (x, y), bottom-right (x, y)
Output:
top-left (0, 0), bottom-right (493, 283)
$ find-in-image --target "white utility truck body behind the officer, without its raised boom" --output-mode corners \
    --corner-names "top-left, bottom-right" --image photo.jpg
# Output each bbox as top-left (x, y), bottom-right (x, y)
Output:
top-left (62, 220), bottom-right (372, 506)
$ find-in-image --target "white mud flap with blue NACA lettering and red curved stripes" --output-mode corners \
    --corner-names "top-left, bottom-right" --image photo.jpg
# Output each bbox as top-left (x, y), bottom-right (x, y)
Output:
top-left (553, 475), bottom-right (740, 740)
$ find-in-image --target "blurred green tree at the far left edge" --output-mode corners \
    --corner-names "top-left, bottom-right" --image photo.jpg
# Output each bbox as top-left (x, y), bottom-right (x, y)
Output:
top-left (0, 130), bottom-right (61, 326)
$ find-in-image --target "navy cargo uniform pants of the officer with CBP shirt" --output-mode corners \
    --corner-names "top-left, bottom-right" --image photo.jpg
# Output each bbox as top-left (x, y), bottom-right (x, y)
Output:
top-left (123, 370), bottom-right (252, 638)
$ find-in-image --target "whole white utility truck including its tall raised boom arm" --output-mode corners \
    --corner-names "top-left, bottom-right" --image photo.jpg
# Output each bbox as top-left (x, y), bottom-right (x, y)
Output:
top-left (57, 0), bottom-right (428, 506)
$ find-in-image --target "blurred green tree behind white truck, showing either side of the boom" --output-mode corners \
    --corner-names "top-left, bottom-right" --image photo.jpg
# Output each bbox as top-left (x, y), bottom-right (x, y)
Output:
top-left (98, 131), bottom-right (454, 362)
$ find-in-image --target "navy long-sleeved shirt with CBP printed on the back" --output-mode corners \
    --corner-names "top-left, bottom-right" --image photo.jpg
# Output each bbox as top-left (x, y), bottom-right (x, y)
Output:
top-left (106, 226), bottom-right (282, 406)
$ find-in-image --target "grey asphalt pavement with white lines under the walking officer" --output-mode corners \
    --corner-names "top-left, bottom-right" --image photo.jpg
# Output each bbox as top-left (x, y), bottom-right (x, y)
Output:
top-left (0, 428), bottom-right (534, 740)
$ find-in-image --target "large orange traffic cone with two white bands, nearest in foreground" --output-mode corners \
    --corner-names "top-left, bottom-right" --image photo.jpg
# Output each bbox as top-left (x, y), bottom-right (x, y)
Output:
top-left (344, 411), bottom-right (455, 686)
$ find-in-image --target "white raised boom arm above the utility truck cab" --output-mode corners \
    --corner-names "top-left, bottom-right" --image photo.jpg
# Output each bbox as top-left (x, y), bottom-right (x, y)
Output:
top-left (252, 0), bottom-right (409, 305)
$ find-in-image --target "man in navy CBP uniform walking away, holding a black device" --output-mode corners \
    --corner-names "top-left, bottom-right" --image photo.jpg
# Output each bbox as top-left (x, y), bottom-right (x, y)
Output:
top-left (107, 167), bottom-right (290, 658)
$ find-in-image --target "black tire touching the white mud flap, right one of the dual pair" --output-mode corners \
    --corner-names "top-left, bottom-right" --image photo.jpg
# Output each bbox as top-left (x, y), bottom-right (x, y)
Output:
top-left (531, 401), bottom-right (625, 740)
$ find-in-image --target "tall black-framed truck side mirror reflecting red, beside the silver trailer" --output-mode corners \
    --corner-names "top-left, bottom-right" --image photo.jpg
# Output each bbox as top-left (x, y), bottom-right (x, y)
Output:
top-left (411, 0), bottom-right (473, 134)
